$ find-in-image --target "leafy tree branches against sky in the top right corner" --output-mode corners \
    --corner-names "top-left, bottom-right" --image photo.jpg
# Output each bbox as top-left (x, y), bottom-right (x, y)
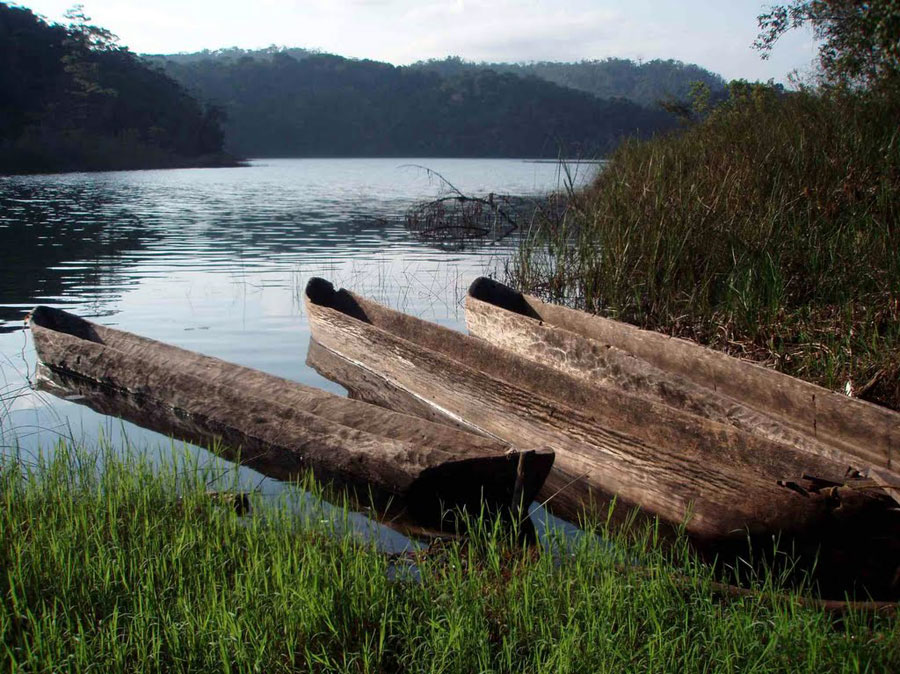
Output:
top-left (754, 0), bottom-right (900, 88)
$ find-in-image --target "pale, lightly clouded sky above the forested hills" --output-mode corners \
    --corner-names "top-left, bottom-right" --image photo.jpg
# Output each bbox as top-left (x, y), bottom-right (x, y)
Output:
top-left (17, 0), bottom-right (816, 82)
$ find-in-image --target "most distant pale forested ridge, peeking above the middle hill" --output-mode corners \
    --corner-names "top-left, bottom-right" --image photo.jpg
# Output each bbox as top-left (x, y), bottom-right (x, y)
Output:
top-left (412, 56), bottom-right (726, 106)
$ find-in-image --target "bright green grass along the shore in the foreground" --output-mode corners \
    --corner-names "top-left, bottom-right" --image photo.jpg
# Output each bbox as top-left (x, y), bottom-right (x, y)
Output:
top-left (0, 438), bottom-right (900, 673)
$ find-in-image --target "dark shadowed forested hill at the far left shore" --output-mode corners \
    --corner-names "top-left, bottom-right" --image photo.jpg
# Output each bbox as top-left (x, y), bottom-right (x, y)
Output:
top-left (0, 3), bottom-right (232, 173)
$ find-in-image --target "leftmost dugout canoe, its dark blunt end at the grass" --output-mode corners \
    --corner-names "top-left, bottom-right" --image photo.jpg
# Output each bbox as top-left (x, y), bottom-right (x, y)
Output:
top-left (28, 306), bottom-right (553, 524)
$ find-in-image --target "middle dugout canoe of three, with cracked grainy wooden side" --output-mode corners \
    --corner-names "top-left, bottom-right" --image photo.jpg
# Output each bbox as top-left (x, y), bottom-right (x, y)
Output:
top-left (304, 278), bottom-right (900, 598)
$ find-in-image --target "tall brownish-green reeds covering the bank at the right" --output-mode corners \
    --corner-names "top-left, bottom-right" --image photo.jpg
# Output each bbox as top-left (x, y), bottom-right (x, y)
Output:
top-left (509, 84), bottom-right (900, 409)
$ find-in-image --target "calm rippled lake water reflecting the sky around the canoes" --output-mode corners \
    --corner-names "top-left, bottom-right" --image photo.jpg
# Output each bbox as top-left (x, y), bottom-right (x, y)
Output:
top-left (0, 159), bottom-right (596, 544)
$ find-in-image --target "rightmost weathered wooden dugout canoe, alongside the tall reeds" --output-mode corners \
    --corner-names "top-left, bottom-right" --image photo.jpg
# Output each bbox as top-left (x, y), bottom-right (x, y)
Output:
top-left (466, 278), bottom-right (900, 469)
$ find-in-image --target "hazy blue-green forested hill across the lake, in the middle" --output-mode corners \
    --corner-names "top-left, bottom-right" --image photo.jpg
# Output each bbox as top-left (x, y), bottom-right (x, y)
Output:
top-left (148, 49), bottom-right (675, 157)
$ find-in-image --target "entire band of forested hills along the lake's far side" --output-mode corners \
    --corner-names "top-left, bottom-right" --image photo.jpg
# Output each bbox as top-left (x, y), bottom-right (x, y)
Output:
top-left (0, 2), bottom-right (723, 172)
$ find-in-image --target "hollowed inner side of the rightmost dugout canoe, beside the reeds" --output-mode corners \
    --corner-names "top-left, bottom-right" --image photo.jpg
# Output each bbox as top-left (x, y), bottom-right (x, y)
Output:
top-left (467, 277), bottom-right (900, 470)
